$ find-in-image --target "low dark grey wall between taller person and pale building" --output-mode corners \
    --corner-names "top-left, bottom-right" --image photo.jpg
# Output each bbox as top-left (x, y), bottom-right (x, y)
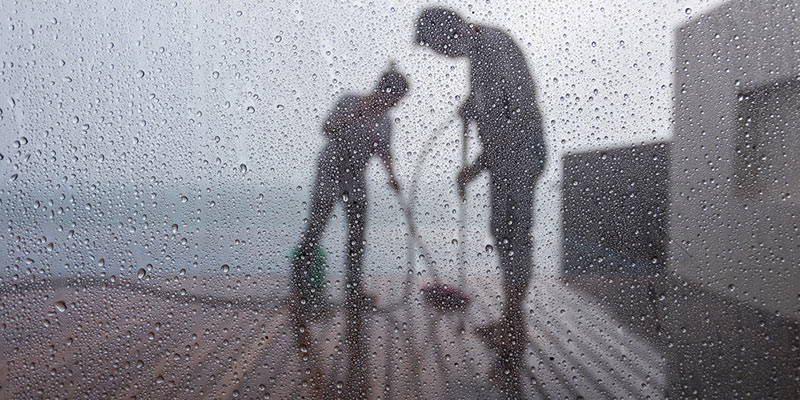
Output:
top-left (562, 143), bottom-right (669, 273)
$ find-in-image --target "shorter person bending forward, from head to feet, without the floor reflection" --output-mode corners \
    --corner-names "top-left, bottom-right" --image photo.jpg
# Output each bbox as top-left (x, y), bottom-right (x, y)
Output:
top-left (293, 64), bottom-right (408, 306)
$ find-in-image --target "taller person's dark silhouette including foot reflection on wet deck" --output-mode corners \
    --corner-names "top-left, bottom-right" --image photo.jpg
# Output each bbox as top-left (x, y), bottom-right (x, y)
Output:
top-left (416, 8), bottom-right (545, 397)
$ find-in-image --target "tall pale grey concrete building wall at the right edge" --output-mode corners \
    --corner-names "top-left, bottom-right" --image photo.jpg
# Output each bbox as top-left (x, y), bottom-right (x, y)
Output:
top-left (670, 0), bottom-right (800, 320)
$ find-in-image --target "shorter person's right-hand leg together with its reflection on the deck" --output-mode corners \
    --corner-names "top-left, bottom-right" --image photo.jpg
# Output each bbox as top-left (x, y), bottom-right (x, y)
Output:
top-left (344, 182), bottom-right (369, 399)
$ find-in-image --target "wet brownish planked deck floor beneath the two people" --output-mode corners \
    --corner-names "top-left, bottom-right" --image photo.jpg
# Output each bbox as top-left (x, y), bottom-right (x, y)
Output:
top-left (0, 277), bottom-right (666, 399)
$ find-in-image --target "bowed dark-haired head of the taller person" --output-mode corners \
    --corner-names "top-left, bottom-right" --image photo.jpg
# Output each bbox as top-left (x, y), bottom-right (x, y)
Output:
top-left (416, 7), bottom-right (472, 57)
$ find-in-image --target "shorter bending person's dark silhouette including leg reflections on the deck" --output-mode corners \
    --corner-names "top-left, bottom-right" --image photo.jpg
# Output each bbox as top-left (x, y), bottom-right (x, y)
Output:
top-left (292, 67), bottom-right (408, 398)
